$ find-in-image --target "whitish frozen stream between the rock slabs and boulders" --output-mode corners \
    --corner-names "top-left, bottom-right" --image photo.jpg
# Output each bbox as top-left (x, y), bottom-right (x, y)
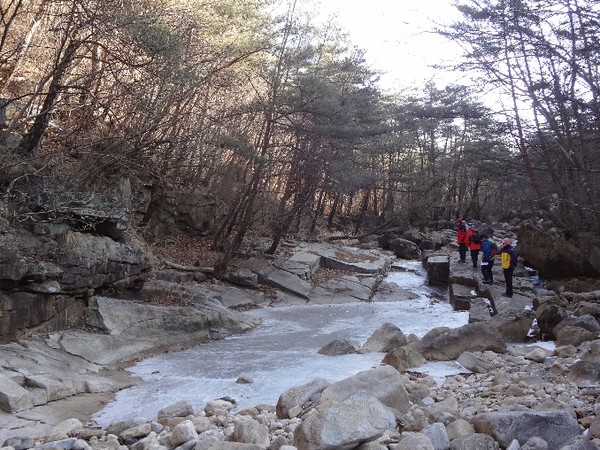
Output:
top-left (94, 262), bottom-right (468, 427)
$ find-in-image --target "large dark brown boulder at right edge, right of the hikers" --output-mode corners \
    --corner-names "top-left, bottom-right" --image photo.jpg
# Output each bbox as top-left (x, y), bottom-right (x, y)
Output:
top-left (517, 224), bottom-right (600, 278)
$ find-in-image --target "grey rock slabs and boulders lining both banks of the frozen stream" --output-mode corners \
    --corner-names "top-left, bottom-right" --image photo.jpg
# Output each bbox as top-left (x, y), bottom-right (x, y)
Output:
top-left (0, 237), bottom-right (600, 450)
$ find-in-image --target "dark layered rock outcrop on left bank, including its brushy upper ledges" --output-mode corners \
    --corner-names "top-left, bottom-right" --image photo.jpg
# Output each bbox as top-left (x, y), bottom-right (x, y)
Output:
top-left (0, 176), bottom-right (219, 343)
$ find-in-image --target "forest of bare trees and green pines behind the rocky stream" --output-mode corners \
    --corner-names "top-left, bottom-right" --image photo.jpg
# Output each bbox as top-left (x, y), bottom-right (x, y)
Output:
top-left (0, 0), bottom-right (600, 264)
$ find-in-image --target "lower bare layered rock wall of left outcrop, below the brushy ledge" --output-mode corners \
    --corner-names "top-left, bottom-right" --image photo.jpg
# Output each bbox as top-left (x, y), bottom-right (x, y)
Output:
top-left (0, 218), bottom-right (149, 342)
